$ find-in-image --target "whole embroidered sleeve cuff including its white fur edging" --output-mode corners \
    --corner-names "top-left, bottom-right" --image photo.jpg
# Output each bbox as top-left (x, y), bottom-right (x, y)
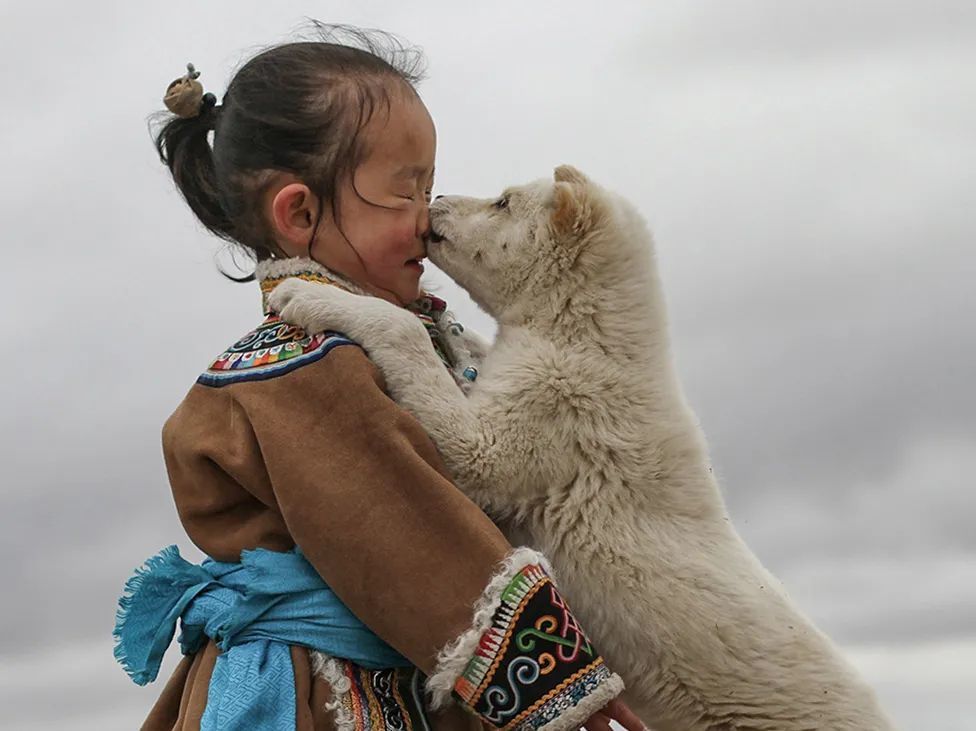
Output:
top-left (427, 548), bottom-right (623, 731)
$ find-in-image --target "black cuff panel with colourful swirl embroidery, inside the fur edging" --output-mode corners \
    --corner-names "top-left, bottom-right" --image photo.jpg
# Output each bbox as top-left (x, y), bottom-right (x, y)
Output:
top-left (454, 564), bottom-right (612, 731)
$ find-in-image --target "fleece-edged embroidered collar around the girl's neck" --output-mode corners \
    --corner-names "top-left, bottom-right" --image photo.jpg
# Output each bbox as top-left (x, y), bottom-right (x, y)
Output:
top-left (254, 257), bottom-right (478, 390)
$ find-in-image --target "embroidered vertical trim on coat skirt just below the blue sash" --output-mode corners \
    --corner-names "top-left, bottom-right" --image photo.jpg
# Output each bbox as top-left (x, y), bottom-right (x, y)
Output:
top-left (339, 660), bottom-right (430, 731)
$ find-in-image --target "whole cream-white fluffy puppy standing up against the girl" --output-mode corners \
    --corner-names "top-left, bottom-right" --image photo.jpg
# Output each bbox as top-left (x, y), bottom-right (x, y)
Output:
top-left (271, 166), bottom-right (892, 731)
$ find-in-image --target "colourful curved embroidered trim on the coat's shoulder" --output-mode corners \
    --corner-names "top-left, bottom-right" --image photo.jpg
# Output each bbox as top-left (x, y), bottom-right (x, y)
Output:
top-left (197, 315), bottom-right (355, 387)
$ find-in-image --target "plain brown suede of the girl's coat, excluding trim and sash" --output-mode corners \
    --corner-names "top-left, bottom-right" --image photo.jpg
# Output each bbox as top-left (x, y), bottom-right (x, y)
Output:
top-left (143, 345), bottom-right (511, 731)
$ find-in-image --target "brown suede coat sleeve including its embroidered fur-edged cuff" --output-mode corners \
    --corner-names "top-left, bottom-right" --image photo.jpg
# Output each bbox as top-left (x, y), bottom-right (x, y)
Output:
top-left (233, 345), bottom-right (623, 731)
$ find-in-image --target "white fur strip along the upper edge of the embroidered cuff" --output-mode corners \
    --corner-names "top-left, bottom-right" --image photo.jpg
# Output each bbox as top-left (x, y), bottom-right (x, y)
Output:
top-left (426, 546), bottom-right (555, 711)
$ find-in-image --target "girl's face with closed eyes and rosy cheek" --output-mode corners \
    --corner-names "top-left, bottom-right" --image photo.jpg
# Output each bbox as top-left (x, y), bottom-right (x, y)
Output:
top-left (309, 91), bottom-right (437, 305)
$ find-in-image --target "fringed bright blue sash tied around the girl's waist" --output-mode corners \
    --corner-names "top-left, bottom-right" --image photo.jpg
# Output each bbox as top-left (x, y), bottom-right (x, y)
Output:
top-left (114, 546), bottom-right (410, 731)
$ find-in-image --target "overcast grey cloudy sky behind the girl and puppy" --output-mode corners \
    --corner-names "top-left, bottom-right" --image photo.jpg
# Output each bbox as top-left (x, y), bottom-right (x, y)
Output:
top-left (0, 0), bottom-right (976, 731)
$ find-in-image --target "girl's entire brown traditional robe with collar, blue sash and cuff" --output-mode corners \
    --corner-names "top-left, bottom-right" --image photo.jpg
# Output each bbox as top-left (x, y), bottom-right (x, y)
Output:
top-left (130, 260), bottom-right (623, 731)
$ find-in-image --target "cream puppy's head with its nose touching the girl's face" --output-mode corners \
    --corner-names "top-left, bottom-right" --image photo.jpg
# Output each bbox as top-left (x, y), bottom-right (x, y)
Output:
top-left (428, 165), bottom-right (611, 318)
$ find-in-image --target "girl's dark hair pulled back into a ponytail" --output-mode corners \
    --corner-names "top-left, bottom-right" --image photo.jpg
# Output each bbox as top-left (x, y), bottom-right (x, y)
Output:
top-left (155, 21), bottom-right (424, 280)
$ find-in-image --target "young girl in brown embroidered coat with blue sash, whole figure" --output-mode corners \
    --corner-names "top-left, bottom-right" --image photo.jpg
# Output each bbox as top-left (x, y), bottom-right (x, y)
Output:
top-left (116, 25), bottom-right (641, 731)
